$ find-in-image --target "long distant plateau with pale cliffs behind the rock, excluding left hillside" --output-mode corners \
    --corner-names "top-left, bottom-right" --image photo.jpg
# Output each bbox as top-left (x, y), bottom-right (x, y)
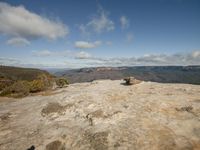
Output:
top-left (55, 66), bottom-right (200, 84)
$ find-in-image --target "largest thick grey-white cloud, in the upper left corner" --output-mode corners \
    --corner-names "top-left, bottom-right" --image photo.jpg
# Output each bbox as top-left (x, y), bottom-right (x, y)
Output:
top-left (0, 2), bottom-right (69, 40)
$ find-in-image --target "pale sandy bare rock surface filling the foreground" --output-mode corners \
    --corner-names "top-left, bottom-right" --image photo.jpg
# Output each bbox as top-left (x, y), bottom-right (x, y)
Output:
top-left (0, 80), bottom-right (200, 150)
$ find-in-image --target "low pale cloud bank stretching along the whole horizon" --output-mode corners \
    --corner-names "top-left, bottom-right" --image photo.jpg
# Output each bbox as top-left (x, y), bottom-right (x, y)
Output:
top-left (0, 50), bottom-right (200, 68)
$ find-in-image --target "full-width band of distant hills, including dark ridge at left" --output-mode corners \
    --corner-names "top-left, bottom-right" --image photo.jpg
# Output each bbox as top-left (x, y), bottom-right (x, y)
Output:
top-left (0, 66), bottom-right (200, 84)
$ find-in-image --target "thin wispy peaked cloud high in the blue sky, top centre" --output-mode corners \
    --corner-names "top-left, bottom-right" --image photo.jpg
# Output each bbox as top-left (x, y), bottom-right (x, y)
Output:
top-left (79, 9), bottom-right (115, 35)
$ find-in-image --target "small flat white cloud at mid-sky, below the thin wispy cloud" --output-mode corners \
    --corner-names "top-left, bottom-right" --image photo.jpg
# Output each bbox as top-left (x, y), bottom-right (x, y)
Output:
top-left (75, 41), bottom-right (101, 49)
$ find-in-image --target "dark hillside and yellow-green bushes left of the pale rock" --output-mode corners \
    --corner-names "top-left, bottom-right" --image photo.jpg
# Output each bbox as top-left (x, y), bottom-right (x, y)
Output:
top-left (0, 66), bottom-right (68, 98)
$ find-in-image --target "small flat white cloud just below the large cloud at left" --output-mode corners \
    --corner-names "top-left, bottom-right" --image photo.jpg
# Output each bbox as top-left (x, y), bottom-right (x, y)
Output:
top-left (7, 37), bottom-right (30, 46)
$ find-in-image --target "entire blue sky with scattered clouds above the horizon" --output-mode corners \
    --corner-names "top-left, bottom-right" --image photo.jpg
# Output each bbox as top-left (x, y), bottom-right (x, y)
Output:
top-left (0, 0), bottom-right (200, 68)
